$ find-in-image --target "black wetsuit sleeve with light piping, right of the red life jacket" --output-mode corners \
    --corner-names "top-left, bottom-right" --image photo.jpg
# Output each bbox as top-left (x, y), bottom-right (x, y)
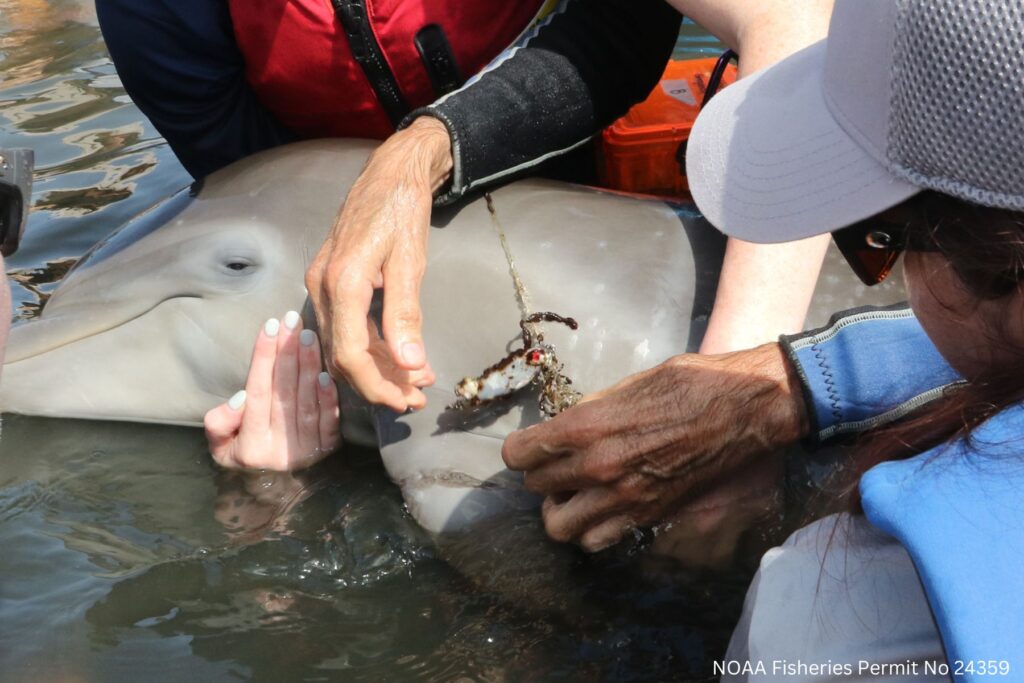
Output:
top-left (403, 0), bottom-right (681, 204)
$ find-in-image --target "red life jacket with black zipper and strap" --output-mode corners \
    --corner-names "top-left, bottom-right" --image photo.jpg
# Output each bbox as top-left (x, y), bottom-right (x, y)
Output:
top-left (228, 0), bottom-right (544, 138)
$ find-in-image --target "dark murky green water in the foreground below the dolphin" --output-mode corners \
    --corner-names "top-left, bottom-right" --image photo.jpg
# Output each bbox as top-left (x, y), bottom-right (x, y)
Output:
top-left (0, 417), bottom-right (782, 681)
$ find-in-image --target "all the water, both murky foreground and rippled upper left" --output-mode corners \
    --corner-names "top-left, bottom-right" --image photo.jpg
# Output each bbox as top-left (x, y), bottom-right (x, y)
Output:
top-left (0, 7), bottom-right (864, 683)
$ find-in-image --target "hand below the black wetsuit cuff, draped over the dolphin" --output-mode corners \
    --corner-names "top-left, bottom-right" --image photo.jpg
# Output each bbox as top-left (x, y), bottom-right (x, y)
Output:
top-left (306, 117), bottom-right (452, 413)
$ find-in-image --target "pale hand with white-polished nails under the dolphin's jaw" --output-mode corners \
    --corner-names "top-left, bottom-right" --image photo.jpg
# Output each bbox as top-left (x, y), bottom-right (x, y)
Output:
top-left (204, 310), bottom-right (341, 470)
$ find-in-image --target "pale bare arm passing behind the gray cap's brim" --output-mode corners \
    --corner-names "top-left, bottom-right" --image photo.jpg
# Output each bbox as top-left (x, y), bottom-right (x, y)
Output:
top-left (671, 0), bottom-right (833, 353)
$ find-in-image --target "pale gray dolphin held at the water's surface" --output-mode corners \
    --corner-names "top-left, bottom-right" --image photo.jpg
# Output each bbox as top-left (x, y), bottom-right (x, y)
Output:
top-left (0, 140), bottom-right (897, 532)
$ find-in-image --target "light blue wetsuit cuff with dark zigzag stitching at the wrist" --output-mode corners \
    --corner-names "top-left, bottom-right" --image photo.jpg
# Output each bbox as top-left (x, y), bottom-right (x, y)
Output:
top-left (780, 304), bottom-right (962, 446)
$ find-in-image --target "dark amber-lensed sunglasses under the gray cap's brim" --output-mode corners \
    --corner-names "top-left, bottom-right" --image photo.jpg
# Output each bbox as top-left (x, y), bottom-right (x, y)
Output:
top-left (833, 212), bottom-right (907, 287)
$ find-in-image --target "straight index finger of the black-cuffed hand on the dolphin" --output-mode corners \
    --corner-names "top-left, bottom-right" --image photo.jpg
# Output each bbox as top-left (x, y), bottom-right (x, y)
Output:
top-left (382, 229), bottom-right (430, 370)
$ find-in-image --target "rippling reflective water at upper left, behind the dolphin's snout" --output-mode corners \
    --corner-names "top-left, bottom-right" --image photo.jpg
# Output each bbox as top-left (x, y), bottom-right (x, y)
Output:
top-left (0, 0), bottom-right (189, 318)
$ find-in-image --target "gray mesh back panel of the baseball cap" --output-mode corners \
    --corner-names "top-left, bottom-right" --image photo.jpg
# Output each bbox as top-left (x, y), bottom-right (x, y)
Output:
top-left (888, 0), bottom-right (1024, 209)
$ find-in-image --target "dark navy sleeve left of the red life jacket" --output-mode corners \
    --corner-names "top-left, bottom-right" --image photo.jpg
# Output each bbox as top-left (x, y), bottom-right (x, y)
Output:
top-left (96, 0), bottom-right (295, 178)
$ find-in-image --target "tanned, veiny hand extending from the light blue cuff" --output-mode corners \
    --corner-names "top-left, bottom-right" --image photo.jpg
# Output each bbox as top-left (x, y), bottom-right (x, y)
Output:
top-left (502, 344), bottom-right (807, 550)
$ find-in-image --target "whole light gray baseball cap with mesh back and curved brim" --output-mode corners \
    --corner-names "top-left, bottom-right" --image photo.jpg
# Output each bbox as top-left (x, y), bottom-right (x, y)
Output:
top-left (686, 0), bottom-right (1024, 243)
